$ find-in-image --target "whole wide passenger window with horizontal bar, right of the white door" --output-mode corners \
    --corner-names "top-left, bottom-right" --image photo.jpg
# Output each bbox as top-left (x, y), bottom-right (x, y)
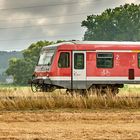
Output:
top-left (96, 53), bottom-right (114, 68)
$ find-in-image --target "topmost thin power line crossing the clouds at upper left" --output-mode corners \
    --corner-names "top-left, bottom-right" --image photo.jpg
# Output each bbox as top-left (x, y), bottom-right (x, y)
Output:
top-left (0, 1), bottom-right (90, 10)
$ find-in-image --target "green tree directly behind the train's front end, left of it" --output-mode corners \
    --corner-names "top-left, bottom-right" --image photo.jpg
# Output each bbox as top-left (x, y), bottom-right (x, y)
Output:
top-left (6, 41), bottom-right (54, 85)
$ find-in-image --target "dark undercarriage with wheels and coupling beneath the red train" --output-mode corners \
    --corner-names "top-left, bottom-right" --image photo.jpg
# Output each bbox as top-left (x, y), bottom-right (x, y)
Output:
top-left (30, 77), bottom-right (124, 96)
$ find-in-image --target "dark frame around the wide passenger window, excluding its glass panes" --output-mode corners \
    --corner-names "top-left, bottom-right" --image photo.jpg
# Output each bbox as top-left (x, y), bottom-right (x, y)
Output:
top-left (96, 52), bottom-right (114, 69)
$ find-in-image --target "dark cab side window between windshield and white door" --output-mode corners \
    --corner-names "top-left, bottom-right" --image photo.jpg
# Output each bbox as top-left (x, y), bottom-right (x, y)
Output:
top-left (58, 52), bottom-right (70, 68)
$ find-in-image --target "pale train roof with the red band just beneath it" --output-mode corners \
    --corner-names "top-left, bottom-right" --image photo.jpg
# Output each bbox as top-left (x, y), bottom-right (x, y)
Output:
top-left (43, 41), bottom-right (140, 50)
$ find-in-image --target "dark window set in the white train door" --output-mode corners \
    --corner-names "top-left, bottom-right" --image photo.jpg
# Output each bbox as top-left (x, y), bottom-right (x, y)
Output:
top-left (74, 53), bottom-right (84, 69)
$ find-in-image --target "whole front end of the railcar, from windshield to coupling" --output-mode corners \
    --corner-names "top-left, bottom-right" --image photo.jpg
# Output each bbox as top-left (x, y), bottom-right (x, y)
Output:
top-left (30, 45), bottom-right (57, 92)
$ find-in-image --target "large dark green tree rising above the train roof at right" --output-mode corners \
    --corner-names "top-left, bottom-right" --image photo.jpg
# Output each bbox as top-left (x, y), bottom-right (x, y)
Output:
top-left (82, 4), bottom-right (140, 41)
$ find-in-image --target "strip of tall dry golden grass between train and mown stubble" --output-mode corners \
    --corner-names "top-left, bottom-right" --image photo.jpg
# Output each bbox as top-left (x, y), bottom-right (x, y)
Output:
top-left (0, 87), bottom-right (140, 111)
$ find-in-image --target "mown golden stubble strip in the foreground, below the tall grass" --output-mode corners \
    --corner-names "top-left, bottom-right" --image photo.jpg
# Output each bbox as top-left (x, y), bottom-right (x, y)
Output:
top-left (0, 110), bottom-right (140, 140)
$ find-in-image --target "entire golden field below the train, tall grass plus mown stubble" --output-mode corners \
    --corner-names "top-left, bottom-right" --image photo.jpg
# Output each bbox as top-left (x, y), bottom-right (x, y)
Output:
top-left (0, 85), bottom-right (140, 140)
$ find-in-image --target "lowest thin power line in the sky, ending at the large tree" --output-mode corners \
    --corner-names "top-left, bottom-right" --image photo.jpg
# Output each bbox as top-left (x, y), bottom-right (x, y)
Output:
top-left (0, 34), bottom-right (83, 41)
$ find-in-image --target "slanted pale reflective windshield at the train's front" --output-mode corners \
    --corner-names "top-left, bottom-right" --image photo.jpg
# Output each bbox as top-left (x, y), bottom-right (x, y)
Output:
top-left (38, 50), bottom-right (54, 66)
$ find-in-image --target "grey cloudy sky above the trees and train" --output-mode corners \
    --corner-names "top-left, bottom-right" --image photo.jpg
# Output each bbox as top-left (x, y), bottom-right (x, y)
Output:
top-left (0, 0), bottom-right (140, 51)
